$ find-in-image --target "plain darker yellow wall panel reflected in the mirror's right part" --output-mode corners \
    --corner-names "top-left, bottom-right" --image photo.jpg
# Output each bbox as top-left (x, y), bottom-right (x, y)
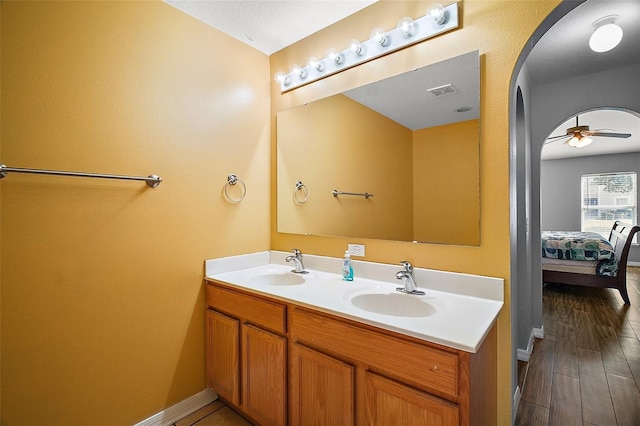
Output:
top-left (413, 120), bottom-right (480, 245)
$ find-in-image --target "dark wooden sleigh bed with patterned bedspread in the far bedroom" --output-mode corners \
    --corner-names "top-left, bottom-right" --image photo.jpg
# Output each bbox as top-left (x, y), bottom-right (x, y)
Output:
top-left (542, 221), bottom-right (640, 305)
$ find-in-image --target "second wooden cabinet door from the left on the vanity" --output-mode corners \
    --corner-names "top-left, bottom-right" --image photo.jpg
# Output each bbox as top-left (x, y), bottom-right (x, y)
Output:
top-left (242, 324), bottom-right (287, 425)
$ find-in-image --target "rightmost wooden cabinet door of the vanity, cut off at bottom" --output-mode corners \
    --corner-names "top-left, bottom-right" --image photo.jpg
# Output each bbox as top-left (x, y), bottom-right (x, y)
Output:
top-left (365, 372), bottom-right (460, 426)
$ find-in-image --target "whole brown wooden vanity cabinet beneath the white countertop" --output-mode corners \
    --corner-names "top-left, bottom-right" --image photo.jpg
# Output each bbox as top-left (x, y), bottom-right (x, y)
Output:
top-left (207, 281), bottom-right (497, 426)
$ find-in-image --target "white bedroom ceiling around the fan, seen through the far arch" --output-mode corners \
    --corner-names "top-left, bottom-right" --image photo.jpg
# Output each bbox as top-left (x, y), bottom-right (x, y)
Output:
top-left (541, 109), bottom-right (640, 160)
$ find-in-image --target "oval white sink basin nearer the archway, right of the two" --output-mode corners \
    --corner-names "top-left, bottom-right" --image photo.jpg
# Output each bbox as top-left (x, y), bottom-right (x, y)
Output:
top-left (351, 293), bottom-right (436, 317)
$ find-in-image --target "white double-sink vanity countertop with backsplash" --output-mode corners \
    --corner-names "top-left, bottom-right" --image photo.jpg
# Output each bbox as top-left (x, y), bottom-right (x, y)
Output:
top-left (205, 251), bottom-right (504, 352)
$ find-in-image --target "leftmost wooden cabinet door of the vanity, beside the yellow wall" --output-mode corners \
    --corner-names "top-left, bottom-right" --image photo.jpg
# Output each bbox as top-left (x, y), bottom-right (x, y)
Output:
top-left (206, 309), bottom-right (240, 405)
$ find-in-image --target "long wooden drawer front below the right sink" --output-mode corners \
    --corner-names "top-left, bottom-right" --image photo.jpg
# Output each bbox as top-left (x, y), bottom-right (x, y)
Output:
top-left (291, 308), bottom-right (460, 399)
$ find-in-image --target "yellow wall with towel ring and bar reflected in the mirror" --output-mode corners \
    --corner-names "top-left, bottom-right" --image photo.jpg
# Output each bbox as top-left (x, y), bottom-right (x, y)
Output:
top-left (278, 95), bottom-right (413, 241)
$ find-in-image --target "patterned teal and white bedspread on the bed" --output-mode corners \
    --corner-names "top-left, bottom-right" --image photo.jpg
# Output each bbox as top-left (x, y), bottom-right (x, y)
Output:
top-left (542, 231), bottom-right (618, 276)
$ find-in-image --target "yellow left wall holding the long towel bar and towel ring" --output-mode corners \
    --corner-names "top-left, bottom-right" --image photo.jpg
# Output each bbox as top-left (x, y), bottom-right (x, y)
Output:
top-left (0, 1), bottom-right (271, 425)
